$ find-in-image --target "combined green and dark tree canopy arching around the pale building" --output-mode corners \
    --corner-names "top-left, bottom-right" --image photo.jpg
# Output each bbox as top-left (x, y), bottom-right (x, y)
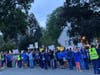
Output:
top-left (42, 0), bottom-right (100, 44)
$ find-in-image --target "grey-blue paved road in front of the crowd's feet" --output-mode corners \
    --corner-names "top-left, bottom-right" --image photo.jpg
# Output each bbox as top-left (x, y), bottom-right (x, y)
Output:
top-left (0, 68), bottom-right (94, 75)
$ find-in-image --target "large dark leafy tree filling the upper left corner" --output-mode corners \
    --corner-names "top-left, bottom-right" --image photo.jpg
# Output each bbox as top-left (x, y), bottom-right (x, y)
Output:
top-left (0, 0), bottom-right (33, 47)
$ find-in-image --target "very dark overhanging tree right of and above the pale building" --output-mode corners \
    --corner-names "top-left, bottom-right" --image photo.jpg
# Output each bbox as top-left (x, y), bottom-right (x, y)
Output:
top-left (64, 0), bottom-right (100, 42)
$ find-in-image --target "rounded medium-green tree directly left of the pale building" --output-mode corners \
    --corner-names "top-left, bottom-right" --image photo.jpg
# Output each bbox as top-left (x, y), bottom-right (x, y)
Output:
top-left (44, 7), bottom-right (66, 45)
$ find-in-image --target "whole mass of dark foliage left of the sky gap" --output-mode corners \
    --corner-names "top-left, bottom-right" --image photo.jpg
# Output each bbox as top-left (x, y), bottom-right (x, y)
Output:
top-left (0, 0), bottom-right (41, 49)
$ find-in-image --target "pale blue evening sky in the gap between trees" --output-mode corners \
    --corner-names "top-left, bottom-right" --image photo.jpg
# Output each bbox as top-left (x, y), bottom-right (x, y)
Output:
top-left (30, 0), bottom-right (65, 27)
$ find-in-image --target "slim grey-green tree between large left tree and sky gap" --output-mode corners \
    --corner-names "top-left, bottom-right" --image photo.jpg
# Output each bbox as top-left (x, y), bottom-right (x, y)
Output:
top-left (28, 13), bottom-right (42, 45)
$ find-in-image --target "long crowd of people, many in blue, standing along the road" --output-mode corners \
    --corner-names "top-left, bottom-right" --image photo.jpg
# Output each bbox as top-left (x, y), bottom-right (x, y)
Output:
top-left (0, 45), bottom-right (100, 74)
